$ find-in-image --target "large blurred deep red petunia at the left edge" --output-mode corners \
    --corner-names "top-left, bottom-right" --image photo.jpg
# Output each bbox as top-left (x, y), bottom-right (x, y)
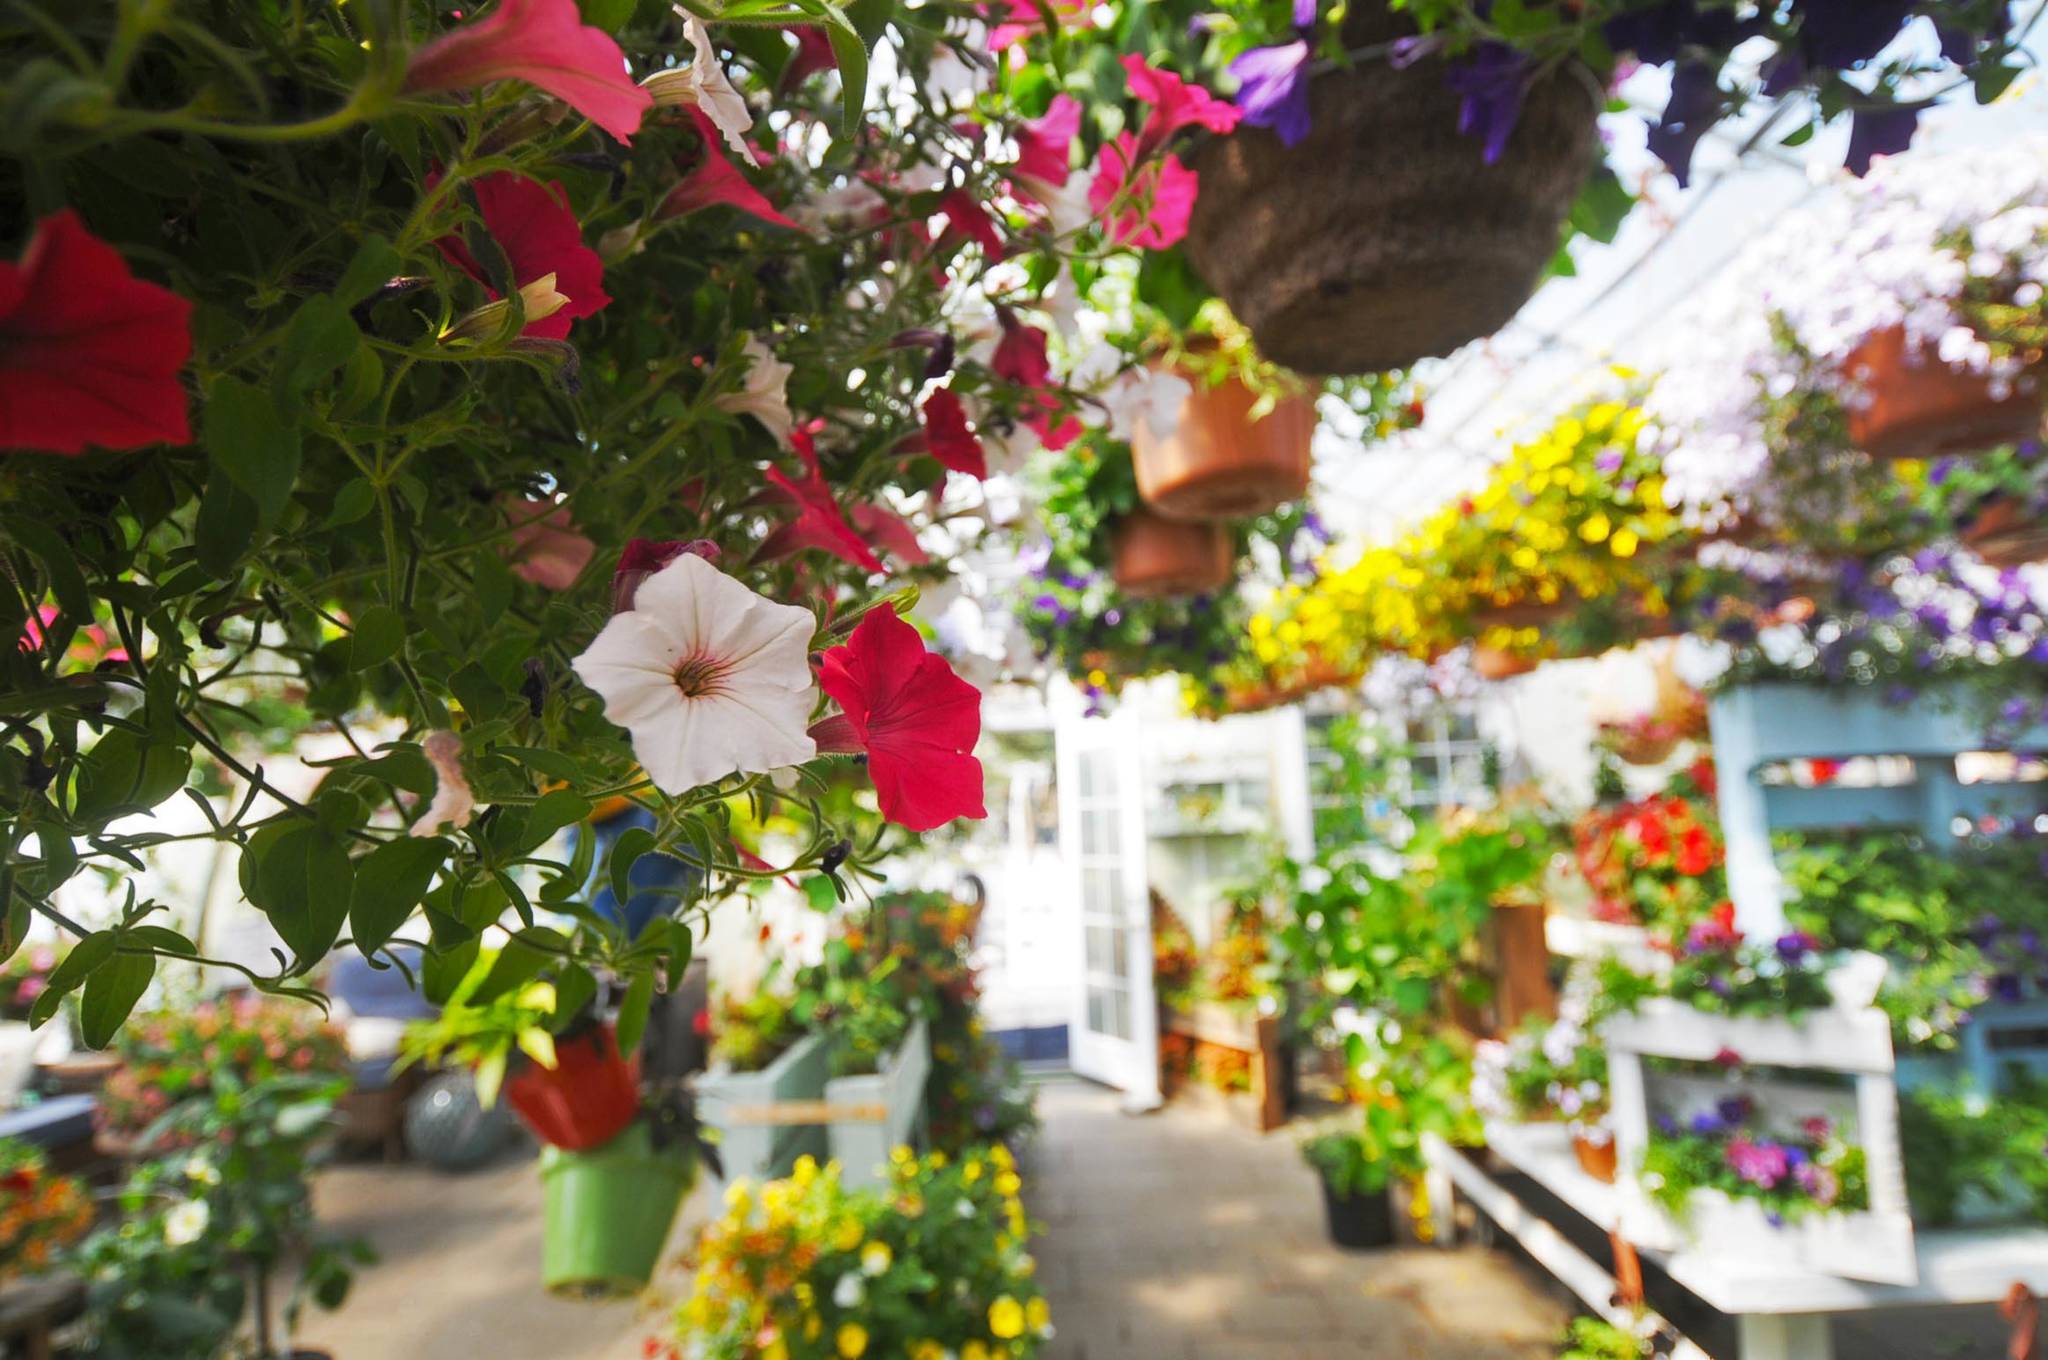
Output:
top-left (0, 209), bottom-right (193, 453)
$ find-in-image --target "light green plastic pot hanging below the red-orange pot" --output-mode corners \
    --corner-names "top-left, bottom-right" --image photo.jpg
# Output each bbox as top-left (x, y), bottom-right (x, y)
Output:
top-left (541, 1122), bottom-right (696, 1299)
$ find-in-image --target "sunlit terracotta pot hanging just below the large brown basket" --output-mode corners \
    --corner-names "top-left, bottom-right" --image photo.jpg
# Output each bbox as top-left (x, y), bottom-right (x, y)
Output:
top-left (1130, 373), bottom-right (1315, 520)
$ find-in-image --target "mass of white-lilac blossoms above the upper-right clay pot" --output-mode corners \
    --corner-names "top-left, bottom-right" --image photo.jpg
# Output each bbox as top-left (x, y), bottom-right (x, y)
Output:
top-left (1642, 137), bottom-right (2048, 528)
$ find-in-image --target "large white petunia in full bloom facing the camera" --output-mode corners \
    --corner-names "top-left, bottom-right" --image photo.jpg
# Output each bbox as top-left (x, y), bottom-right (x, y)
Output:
top-left (573, 553), bottom-right (817, 795)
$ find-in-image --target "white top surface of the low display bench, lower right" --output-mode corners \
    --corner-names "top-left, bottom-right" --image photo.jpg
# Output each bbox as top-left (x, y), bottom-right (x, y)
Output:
top-left (1487, 1124), bottom-right (2048, 1317)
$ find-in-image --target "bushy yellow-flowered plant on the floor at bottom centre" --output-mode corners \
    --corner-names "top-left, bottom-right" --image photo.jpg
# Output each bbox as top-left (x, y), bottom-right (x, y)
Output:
top-left (668, 1145), bottom-right (1053, 1360)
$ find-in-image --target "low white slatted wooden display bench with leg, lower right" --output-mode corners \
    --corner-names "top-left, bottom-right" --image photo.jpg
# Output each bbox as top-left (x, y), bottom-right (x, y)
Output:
top-left (1430, 1124), bottom-right (2048, 1360)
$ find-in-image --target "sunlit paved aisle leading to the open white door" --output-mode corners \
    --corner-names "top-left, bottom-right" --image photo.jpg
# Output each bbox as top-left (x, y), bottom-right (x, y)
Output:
top-left (1024, 1081), bottom-right (1567, 1360)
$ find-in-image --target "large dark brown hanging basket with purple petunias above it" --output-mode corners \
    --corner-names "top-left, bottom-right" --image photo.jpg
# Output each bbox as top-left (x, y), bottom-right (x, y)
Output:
top-left (1188, 0), bottom-right (1597, 373)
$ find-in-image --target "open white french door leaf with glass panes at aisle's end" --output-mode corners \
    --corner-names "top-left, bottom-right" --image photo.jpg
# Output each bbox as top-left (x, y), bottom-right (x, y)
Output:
top-left (1057, 709), bottom-right (1159, 1110)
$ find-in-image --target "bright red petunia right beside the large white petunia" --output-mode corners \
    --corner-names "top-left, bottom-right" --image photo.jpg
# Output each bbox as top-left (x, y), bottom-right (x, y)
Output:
top-left (811, 606), bottom-right (989, 832)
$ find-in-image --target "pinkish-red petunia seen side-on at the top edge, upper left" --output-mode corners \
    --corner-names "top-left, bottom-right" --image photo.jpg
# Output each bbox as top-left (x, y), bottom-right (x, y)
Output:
top-left (406, 0), bottom-right (653, 141)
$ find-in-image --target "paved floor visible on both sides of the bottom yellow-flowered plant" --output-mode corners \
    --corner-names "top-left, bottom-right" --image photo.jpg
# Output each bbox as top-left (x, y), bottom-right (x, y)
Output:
top-left (299, 1081), bottom-right (1565, 1360)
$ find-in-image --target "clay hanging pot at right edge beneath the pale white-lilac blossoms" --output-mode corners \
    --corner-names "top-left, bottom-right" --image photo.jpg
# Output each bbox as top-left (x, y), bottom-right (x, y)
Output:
top-left (1845, 326), bottom-right (2042, 459)
